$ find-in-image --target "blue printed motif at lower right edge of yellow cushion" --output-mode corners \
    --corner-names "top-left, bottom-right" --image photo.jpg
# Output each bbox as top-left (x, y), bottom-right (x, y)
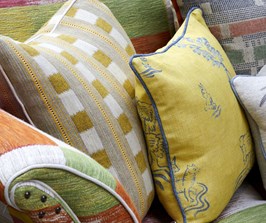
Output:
top-left (235, 133), bottom-right (254, 189)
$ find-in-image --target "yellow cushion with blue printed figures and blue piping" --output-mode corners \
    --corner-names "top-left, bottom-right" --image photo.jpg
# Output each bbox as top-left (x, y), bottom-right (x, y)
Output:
top-left (130, 8), bottom-right (254, 223)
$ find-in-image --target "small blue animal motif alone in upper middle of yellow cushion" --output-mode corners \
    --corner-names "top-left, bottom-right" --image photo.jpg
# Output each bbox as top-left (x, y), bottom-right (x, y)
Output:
top-left (199, 83), bottom-right (222, 118)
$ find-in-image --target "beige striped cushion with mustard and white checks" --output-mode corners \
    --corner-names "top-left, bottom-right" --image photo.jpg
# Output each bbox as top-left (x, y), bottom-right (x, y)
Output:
top-left (0, 0), bottom-right (154, 217)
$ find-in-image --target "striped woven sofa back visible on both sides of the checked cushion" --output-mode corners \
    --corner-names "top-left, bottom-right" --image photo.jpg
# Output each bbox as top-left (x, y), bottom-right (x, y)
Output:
top-left (0, 0), bottom-right (174, 53)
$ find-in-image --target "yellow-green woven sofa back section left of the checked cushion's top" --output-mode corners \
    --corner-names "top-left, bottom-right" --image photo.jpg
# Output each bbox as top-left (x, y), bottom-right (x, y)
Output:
top-left (0, 0), bottom-right (67, 41)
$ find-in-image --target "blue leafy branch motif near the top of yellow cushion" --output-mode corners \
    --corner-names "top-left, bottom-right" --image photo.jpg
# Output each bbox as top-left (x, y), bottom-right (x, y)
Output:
top-left (176, 37), bottom-right (232, 78)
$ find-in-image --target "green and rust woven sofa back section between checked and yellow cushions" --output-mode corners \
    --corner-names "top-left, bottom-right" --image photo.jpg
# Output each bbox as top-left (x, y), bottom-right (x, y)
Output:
top-left (102, 0), bottom-right (174, 53)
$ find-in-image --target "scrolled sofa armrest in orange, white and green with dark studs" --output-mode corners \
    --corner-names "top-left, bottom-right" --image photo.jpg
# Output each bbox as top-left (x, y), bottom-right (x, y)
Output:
top-left (0, 110), bottom-right (140, 223)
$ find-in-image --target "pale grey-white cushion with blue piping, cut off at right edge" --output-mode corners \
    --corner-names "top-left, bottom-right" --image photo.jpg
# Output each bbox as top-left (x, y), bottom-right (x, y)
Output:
top-left (232, 75), bottom-right (266, 189)
